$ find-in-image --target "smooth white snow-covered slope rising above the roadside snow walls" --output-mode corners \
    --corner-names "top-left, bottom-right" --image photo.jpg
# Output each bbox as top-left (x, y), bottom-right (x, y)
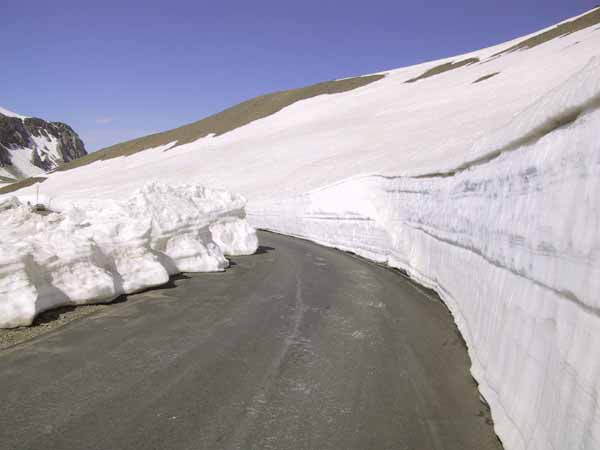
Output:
top-left (10, 10), bottom-right (600, 200)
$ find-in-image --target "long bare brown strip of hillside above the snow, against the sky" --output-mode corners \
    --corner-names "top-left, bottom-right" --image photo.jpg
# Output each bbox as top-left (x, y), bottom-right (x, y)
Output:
top-left (58, 75), bottom-right (385, 171)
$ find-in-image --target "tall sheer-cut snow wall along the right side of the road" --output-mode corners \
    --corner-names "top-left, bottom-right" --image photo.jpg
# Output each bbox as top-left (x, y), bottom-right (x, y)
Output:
top-left (248, 60), bottom-right (600, 450)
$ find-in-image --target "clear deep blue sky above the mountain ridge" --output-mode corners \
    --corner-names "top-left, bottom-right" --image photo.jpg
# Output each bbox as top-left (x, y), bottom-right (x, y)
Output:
top-left (0, 0), bottom-right (598, 150)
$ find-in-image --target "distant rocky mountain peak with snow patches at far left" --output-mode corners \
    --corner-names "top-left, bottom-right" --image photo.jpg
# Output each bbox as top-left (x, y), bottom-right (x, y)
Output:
top-left (0, 108), bottom-right (87, 182)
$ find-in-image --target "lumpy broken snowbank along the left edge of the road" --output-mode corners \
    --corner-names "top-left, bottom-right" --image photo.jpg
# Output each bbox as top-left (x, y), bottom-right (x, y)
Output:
top-left (0, 183), bottom-right (258, 328)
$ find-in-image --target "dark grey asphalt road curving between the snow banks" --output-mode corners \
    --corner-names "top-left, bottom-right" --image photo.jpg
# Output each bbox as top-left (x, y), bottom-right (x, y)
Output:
top-left (0, 233), bottom-right (501, 450)
